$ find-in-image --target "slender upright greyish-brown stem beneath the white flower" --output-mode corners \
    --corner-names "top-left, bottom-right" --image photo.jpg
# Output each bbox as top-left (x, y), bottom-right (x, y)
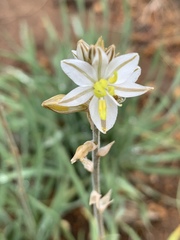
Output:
top-left (91, 124), bottom-right (105, 240)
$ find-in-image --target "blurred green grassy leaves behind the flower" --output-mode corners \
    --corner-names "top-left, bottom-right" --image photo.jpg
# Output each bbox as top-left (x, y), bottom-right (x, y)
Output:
top-left (0, 0), bottom-right (180, 240)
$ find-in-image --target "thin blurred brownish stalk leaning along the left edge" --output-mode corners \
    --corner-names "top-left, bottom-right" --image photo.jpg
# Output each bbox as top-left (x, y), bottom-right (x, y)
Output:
top-left (0, 103), bottom-right (35, 238)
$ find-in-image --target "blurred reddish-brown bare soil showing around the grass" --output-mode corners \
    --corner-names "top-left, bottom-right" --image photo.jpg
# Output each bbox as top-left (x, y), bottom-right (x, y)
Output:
top-left (0, 0), bottom-right (180, 240)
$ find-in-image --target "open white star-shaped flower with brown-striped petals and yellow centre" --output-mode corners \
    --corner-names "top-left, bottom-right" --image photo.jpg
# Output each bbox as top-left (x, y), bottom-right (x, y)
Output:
top-left (58, 46), bottom-right (152, 133)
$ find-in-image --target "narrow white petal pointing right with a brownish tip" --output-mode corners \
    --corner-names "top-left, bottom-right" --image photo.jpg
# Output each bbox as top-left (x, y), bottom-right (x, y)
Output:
top-left (115, 82), bottom-right (153, 98)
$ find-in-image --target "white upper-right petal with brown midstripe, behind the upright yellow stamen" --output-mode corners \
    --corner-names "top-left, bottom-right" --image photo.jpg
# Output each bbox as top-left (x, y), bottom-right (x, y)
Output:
top-left (106, 53), bottom-right (139, 83)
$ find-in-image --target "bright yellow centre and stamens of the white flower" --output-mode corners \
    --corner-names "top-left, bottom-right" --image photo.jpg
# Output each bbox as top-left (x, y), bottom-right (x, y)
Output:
top-left (93, 72), bottom-right (117, 121)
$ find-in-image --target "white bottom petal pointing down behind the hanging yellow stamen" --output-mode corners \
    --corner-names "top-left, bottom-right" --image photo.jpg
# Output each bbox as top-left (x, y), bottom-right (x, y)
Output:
top-left (89, 95), bottom-right (118, 133)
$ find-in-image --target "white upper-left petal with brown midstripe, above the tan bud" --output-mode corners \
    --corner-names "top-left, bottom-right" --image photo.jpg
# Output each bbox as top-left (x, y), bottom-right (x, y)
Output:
top-left (61, 59), bottom-right (96, 86)
